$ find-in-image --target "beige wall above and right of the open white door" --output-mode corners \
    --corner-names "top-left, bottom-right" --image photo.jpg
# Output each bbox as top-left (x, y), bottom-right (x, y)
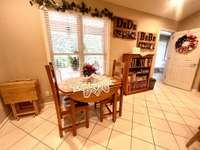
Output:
top-left (177, 11), bottom-right (200, 91)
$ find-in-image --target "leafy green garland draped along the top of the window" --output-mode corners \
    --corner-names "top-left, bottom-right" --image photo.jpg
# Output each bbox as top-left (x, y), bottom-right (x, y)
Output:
top-left (30, 0), bottom-right (113, 19)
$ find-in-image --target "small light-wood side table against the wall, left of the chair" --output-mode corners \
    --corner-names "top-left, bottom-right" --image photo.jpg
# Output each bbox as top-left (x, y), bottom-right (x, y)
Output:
top-left (0, 80), bottom-right (39, 119)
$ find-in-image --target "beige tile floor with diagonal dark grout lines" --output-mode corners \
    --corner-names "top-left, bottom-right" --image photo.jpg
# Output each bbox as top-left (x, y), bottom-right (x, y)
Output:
top-left (0, 83), bottom-right (200, 150)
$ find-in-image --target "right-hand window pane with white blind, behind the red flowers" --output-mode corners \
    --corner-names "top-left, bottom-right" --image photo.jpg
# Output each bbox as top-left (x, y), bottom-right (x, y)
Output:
top-left (82, 17), bottom-right (105, 74)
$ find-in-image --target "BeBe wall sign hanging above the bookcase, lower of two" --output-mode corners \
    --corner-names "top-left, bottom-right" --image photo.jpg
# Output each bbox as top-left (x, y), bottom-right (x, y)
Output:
top-left (137, 32), bottom-right (156, 50)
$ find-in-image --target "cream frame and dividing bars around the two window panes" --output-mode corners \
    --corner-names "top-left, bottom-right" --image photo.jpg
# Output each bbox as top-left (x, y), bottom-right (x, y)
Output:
top-left (41, 10), bottom-right (110, 75)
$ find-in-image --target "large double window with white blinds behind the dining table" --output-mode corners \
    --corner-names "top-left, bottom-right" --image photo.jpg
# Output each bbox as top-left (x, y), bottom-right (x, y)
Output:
top-left (45, 11), bottom-right (107, 79)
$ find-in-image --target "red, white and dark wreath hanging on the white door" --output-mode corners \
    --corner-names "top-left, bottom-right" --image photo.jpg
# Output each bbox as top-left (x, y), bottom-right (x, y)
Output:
top-left (175, 34), bottom-right (198, 54)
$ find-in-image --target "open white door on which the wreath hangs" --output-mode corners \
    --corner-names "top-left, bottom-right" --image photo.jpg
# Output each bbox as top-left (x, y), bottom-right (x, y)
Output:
top-left (164, 29), bottom-right (200, 90)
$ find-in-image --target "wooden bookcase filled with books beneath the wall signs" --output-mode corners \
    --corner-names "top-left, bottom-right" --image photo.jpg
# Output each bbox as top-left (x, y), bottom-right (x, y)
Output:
top-left (123, 54), bottom-right (153, 95)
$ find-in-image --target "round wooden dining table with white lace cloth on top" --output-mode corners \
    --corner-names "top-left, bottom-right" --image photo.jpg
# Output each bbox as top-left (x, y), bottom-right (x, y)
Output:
top-left (58, 75), bottom-right (122, 135)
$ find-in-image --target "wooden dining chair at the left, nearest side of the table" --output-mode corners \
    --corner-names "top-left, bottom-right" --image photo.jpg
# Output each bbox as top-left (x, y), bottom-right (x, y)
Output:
top-left (45, 63), bottom-right (89, 137)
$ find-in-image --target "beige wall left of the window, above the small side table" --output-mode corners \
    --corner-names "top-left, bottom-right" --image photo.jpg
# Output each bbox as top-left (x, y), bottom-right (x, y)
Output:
top-left (0, 0), bottom-right (49, 99)
